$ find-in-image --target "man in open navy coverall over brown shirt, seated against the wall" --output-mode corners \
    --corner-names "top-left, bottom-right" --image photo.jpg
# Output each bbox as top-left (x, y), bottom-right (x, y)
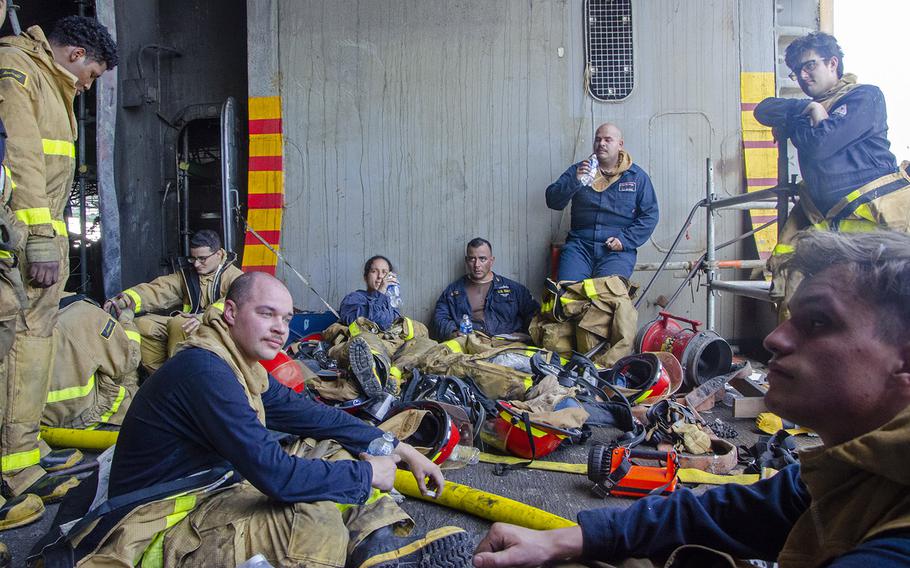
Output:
top-left (433, 237), bottom-right (540, 341)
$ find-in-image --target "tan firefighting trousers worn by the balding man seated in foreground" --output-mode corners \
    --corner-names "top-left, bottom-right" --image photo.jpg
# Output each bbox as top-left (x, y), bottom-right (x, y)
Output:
top-left (85, 440), bottom-right (414, 568)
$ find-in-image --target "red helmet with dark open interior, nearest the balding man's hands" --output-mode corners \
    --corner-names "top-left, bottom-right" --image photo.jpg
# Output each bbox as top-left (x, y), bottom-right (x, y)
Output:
top-left (387, 400), bottom-right (474, 464)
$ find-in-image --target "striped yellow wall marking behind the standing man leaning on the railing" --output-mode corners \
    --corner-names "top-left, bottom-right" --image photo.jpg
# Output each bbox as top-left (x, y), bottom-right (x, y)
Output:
top-left (740, 72), bottom-right (777, 260)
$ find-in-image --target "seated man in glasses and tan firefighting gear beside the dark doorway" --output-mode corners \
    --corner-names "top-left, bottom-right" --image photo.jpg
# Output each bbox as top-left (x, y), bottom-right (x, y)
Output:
top-left (104, 229), bottom-right (243, 373)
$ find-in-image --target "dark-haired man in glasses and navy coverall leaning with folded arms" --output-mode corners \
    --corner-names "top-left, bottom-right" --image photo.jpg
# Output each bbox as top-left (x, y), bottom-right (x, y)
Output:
top-left (755, 32), bottom-right (910, 316)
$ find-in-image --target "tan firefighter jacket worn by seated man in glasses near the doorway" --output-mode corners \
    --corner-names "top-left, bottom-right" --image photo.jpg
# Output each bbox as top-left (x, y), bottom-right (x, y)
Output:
top-left (123, 253), bottom-right (243, 314)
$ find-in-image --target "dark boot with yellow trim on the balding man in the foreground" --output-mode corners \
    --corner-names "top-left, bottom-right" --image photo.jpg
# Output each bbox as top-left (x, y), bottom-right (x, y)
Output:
top-left (347, 527), bottom-right (474, 568)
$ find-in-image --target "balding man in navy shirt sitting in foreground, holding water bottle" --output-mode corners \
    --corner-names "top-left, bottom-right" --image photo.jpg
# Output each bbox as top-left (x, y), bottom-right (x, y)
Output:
top-left (39, 272), bottom-right (473, 568)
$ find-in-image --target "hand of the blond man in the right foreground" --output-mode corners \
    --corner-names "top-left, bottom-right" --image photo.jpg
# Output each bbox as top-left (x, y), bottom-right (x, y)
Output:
top-left (474, 523), bottom-right (582, 568)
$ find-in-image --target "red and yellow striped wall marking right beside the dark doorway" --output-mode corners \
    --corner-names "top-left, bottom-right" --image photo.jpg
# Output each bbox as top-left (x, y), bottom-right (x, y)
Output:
top-left (242, 97), bottom-right (284, 275)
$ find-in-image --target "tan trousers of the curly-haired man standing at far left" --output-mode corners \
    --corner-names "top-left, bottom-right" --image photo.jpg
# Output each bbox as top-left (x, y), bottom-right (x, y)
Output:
top-left (0, 236), bottom-right (69, 495)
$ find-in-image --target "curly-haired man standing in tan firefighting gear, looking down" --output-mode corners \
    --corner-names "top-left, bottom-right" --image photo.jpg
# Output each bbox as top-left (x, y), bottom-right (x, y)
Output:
top-left (0, 16), bottom-right (117, 502)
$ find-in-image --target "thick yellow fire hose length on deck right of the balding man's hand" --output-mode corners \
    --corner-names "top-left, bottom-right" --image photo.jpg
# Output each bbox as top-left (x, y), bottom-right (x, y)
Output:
top-left (395, 469), bottom-right (575, 530)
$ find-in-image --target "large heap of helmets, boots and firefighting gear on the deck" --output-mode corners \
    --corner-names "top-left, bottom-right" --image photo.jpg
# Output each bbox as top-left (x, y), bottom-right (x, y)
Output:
top-left (264, 310), bottom-right (764, 496)
